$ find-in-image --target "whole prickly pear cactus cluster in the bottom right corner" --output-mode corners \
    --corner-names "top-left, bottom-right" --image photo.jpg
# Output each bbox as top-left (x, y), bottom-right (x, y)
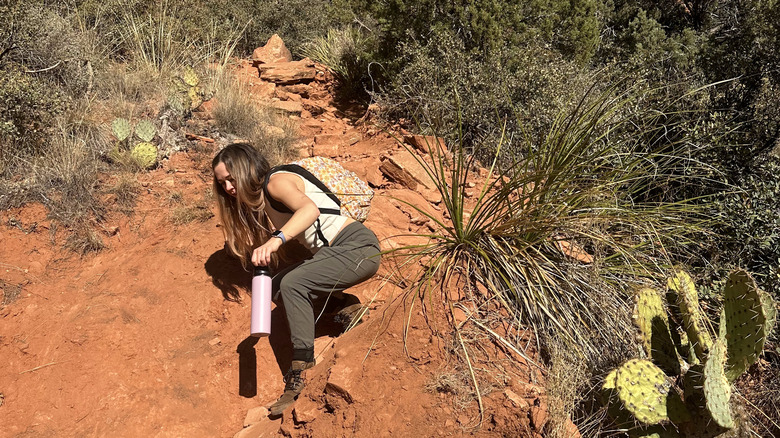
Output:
top-left (602, 270), bottom-right (777, 438)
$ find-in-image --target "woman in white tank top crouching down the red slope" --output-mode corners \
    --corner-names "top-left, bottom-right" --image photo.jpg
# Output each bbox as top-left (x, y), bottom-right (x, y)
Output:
top-left (211, 143), bottom-right (380, 416)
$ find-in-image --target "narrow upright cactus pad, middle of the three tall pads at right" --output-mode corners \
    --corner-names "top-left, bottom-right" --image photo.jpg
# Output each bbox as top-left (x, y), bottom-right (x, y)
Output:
top-left (668, 270), bottom-right (712, 361)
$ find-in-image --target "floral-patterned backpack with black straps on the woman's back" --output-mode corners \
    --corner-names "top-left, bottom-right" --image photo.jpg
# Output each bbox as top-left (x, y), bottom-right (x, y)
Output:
top-left (263, 157), bottom-right (374, 222)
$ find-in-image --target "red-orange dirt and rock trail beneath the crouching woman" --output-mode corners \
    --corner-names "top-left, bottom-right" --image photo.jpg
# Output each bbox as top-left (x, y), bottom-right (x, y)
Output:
top-left (0, 36), bottom-right (564, 438)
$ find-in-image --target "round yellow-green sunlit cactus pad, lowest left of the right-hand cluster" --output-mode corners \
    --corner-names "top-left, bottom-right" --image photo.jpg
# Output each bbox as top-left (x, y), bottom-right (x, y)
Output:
top-left (615, 359), bottom-right (676, 425)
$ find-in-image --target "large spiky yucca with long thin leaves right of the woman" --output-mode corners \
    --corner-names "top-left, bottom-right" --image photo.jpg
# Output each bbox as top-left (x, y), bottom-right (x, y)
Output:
top-left (390, 79), bottom-right (703, 365)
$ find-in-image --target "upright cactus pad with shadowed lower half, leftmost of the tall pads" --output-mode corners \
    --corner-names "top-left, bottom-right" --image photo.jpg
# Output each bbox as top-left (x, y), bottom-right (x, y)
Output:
top-left (633, 288), bottom-right (680, 375)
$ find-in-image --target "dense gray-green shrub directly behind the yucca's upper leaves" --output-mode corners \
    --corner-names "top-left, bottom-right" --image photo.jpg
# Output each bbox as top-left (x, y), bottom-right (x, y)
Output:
top-left (374, 31), bottom-right (586, 164)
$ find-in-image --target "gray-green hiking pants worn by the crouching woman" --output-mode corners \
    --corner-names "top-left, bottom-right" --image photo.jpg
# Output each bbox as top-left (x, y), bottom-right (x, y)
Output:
top-left (274, 222), bottom-right (380, 350)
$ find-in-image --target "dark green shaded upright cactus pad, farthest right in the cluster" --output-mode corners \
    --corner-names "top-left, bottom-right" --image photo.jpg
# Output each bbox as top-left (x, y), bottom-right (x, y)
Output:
top-left (721, 270), bottom-right (767, 382)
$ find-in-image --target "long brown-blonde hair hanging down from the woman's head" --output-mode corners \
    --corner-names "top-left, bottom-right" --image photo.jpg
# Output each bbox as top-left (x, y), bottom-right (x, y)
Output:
top-left (211, 143), bottom-right (270, 269)
